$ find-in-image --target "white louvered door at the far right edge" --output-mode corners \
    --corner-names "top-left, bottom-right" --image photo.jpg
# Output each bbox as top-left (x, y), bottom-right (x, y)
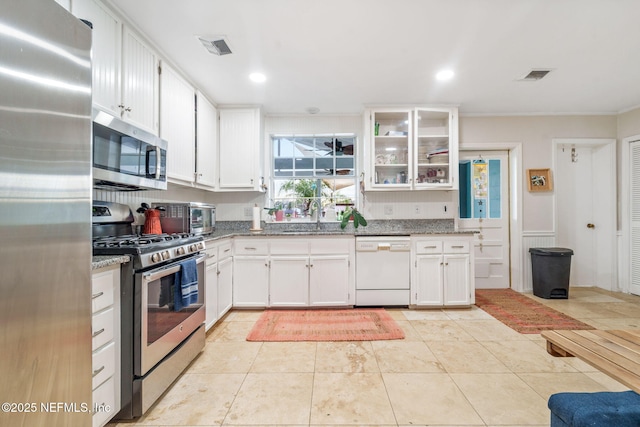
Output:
top-left (629, 141), bottom-right (640, 295)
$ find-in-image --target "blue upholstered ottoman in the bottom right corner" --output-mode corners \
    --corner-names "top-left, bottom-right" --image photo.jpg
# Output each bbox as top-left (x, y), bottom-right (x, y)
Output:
top-left (548, 391), bottom-right (640, 427)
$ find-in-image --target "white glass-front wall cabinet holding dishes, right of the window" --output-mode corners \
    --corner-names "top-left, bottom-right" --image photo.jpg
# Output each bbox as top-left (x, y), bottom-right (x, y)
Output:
top-left (367, 107), bottom-right (458, 190)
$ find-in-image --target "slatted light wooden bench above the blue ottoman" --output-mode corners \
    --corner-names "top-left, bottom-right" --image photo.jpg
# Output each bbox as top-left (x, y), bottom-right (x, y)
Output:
top-left (540, 329), bottom-right (640, 393)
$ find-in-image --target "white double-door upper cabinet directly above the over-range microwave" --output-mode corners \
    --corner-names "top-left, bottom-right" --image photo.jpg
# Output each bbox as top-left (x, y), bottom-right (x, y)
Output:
top-left (71, 0), bottom-right (158, 135)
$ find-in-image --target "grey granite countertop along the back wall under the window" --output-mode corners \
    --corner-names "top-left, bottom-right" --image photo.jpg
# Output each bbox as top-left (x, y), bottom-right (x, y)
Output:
top-left (205, 219), bottom-right (475, 240)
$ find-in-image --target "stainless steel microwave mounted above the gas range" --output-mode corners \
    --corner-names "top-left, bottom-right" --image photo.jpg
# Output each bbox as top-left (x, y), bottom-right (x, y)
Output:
top-left (93, 108), bottom-right (168, 191)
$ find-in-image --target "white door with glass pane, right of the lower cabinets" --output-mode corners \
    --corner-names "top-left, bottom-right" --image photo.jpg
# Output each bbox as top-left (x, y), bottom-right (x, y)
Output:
top-left (458, 151), bottom-right (511, 289)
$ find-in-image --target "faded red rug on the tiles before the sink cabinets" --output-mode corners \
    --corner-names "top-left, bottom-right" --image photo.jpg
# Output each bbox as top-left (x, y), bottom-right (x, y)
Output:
top-left (247, 308), bottom-right (404, 341)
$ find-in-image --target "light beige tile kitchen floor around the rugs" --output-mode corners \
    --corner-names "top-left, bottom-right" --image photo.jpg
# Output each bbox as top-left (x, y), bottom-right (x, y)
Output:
top-left (109, 288), bottom-right (640, 427)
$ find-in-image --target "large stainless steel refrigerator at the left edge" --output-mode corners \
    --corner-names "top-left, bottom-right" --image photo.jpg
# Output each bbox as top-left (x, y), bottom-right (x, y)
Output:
top-left (0, 0), bottom-right (92, 427)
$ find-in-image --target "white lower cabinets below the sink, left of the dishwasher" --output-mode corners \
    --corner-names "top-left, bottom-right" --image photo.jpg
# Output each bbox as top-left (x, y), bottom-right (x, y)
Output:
top-left (233, 236), bottom-right (355, 308)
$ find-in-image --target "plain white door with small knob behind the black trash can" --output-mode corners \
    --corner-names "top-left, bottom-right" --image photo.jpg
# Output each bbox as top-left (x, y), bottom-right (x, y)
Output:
top-left (554, 139), bottom-right (617, 290)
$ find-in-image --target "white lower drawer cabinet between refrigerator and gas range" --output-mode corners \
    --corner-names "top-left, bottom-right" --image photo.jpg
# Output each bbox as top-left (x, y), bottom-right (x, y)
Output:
top-left (91, 264), bottom-right (120, 427)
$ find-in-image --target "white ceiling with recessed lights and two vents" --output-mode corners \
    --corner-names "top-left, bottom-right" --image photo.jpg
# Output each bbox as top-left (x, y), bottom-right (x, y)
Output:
top-left (108, 0), bottom-right (640, 115)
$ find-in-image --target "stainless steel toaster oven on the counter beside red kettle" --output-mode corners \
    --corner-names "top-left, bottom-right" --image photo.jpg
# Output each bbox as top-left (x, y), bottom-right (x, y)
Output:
top-left (152, 203), bottom-right (216, 234)
